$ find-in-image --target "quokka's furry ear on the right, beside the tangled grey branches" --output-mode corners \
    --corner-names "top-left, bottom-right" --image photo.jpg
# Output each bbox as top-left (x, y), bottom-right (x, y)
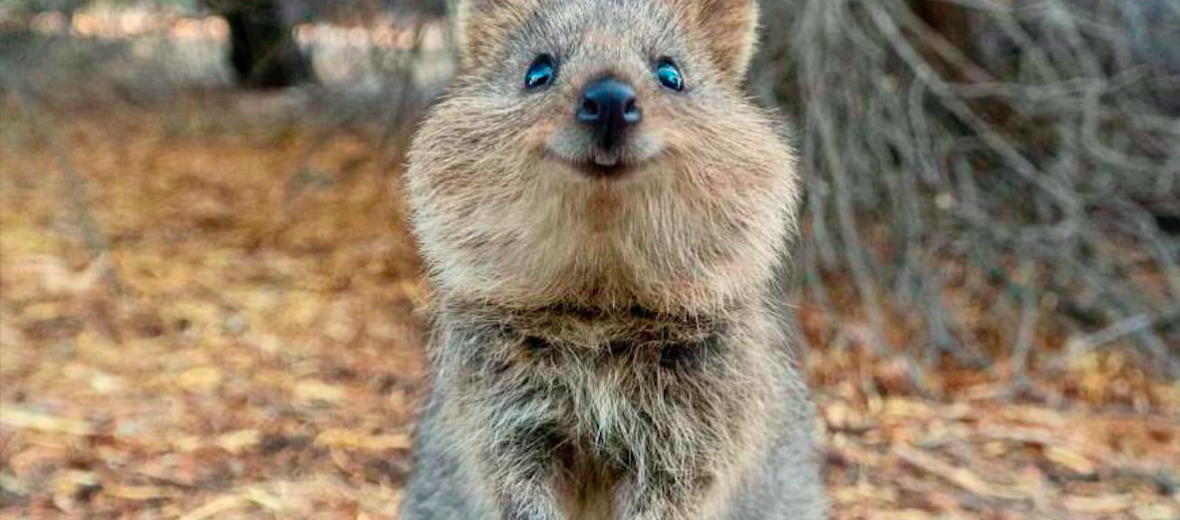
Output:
top-left (681, 0), bottom-right (759, 83)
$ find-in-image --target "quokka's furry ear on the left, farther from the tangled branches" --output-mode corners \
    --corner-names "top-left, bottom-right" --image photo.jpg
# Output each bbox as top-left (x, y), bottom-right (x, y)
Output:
top-left (455, 0), bottom-right (535, 70)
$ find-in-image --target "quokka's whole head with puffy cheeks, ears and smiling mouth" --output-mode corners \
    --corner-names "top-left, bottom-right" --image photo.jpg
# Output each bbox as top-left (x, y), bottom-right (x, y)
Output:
top-left (408, 0), bottom-right (797, 310)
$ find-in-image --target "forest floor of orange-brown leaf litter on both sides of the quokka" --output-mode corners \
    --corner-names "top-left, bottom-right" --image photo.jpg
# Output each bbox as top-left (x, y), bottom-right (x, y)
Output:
top-left (0, 81), bottom-right (1180, 520)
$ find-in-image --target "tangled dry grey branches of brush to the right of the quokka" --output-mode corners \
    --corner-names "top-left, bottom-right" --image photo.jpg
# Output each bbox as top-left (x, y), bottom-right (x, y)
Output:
top-left (755, 0), bottom-right (1180, 379)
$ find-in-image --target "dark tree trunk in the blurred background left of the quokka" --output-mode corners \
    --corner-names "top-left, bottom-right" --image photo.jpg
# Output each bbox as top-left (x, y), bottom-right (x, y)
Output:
top-left (222, 0), bottom-right (315, 88)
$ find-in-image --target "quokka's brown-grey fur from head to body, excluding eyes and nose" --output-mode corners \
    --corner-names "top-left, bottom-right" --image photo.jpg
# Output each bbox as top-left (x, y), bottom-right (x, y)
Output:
top-left (400, 0), bottom-right (825, 520)
